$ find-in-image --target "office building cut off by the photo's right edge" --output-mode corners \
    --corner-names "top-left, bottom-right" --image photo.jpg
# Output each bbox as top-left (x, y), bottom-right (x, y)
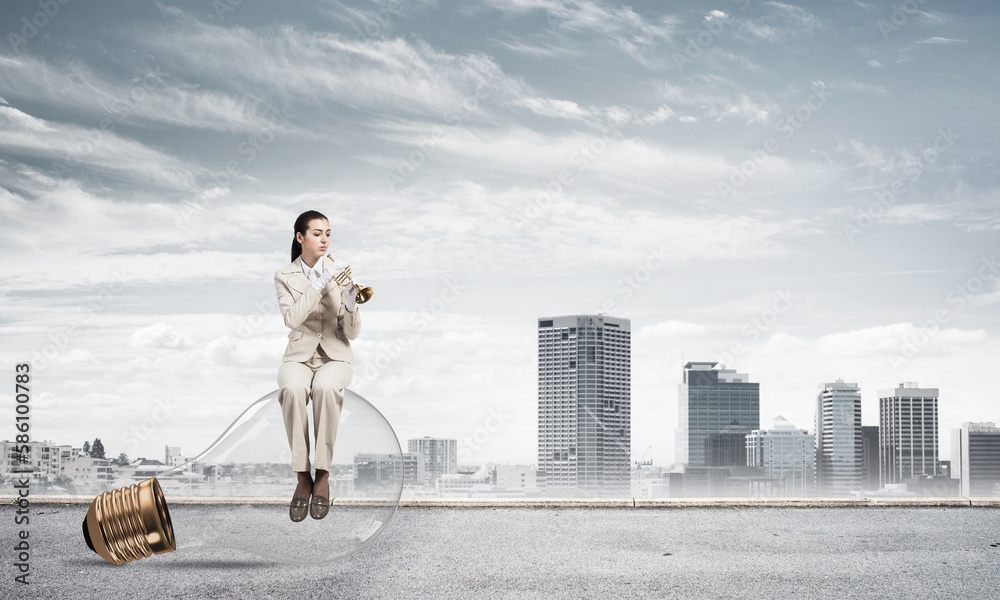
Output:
top-left (951, 423), bottom-right (1000, 497)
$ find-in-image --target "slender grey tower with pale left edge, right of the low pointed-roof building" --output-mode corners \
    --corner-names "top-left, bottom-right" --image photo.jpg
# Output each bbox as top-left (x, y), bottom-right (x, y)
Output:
top-left (816, 379), bottom-right (862, 496)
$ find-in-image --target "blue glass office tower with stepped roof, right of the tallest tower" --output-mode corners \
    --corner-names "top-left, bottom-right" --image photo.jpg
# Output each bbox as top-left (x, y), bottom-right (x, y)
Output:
top-left (675, 362), bottom-right (760, 470)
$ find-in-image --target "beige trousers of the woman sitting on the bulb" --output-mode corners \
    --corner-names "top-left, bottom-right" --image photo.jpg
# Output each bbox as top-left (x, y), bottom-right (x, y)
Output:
top-left (278, 346), bottom-right (354, 472)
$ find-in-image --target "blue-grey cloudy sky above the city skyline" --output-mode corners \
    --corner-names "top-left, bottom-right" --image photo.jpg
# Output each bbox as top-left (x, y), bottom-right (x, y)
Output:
top-left (0, 0), bottom-right (1000, 466)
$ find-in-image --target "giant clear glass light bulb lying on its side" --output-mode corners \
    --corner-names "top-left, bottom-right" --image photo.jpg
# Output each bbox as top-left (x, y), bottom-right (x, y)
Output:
top-left (83, 390), bottom-right (402, 565)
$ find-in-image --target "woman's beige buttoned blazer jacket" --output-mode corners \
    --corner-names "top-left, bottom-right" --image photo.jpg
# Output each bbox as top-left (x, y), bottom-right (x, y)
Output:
top-left (274, 256), bottom-right (361, 362)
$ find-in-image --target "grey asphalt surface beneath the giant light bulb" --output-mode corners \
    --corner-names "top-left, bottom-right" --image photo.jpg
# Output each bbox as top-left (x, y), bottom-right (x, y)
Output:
top-left (0, 504), bottom-right (1000, 599)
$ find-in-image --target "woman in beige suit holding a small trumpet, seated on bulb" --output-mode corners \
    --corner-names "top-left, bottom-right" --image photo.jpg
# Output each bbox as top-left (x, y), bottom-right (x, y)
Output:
top-left (274, 210), bottom-right (361, 522)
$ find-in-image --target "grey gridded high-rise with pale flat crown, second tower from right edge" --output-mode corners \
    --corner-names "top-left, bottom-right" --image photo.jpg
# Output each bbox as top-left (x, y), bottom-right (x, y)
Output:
top-left (878, 381), bottom-right (938, 486)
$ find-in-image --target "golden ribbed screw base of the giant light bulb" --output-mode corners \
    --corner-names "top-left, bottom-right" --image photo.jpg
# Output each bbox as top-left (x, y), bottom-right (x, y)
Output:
top-left (83, 477), bottom-right (177, 565)
